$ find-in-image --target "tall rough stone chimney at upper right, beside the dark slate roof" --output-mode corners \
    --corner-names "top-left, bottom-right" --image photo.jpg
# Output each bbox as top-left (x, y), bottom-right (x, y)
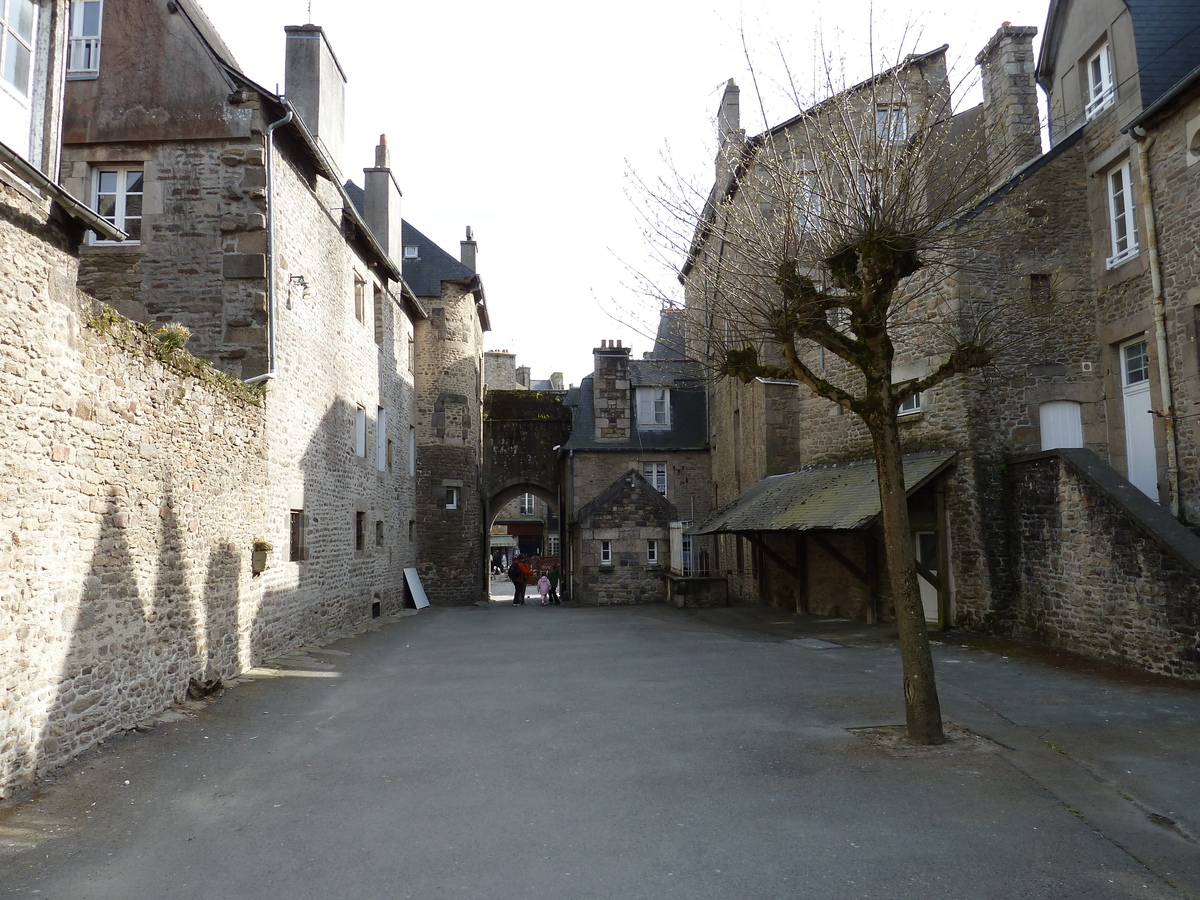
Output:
top-left (976, 22), bottom-right (1042, 176)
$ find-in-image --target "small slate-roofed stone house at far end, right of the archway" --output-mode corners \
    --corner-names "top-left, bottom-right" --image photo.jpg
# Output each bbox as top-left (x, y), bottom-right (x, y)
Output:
top-left (562, 310), bottom-right (712, 604)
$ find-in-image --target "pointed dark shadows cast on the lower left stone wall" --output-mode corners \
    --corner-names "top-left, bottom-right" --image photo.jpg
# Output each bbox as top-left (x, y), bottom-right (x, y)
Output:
top-left (0, 490), bottom-right (244, 793)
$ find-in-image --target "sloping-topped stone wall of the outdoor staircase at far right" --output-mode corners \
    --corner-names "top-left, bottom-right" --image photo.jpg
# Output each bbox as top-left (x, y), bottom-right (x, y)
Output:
top-left (1010, 450), bottom-right (1200, 678)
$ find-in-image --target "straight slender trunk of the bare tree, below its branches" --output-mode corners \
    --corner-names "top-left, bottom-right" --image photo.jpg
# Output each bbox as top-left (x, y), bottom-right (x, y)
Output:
top-left (868, 406), bottom-right (946, 744)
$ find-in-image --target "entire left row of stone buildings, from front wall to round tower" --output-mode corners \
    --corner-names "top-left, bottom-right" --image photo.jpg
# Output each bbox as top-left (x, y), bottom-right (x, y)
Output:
top-left (0, 0), bottom-right (487, 796)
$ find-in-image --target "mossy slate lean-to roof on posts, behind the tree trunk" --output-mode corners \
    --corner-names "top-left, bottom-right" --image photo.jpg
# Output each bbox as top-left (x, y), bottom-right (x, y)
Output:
top-left (690, 451), bottom-right (955, 534)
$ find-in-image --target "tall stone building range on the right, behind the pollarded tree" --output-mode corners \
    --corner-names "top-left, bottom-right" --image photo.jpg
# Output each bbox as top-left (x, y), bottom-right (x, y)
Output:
top-left (683, 12), bottom-right (1200, 677)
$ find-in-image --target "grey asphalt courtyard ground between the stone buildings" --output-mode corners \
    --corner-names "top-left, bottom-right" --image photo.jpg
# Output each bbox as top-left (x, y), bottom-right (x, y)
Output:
top-left (0, 589), bottom-right (1200, 900)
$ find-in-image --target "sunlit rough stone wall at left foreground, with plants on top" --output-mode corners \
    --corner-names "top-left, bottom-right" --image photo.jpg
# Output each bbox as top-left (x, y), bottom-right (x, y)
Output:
top-left (0, 181), bottom-right (274, 796)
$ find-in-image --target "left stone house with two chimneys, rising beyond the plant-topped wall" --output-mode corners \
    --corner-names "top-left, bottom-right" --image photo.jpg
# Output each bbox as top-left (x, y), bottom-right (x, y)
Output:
top-left (62, 0), bottom-right (424, 635)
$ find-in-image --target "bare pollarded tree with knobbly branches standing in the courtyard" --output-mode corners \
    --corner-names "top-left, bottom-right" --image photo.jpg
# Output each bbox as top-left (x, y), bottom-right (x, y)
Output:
top-left (638, 33), bottom-right (1046, 744)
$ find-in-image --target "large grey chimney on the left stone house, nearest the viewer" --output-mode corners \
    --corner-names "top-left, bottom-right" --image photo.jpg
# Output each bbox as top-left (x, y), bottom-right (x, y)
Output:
top-left (283, 25), bottom-right (346, 184)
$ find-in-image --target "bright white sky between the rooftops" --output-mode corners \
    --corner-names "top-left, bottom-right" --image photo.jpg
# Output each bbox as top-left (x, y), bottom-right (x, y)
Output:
top-left (200, 0), bottom-right (1049, 384)
